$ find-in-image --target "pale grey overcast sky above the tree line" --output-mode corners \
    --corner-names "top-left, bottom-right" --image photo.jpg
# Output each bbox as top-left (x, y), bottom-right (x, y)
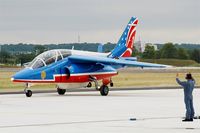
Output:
top-left (0, 0), bottom-right (200, 44)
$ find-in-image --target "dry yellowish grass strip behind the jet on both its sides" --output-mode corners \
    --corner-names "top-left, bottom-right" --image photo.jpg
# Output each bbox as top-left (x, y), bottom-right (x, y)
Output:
top-left (0, 70), bottom-right (200, 91)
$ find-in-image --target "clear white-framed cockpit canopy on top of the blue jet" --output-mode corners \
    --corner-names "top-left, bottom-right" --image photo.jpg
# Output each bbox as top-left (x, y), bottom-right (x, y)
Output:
top-left (28, 49), bottom-right (71, 69)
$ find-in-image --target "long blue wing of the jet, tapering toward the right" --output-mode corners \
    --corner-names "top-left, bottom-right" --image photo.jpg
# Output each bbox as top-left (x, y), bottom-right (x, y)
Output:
top-left (68, 55), bottom-right (170, 68)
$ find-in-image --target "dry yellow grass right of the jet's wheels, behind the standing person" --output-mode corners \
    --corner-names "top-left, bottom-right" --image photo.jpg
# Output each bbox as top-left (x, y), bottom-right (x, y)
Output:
top-left (113, 72), bottom-right (200, 87)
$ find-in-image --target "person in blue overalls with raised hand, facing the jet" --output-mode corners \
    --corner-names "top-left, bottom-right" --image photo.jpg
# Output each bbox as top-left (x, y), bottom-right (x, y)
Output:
top-left (176, 73), bottom-right (195, 122)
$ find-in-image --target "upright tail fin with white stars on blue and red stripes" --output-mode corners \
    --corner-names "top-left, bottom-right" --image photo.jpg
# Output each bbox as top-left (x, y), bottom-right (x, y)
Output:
top-left (108, 17), bottom-right (138, 58)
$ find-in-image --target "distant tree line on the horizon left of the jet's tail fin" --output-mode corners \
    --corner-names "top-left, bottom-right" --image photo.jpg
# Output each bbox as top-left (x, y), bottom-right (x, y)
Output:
top-left (0, 42), bottom-right (115, 65)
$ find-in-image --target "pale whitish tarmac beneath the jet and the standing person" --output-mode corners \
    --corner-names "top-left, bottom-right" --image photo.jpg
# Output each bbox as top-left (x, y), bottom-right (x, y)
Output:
top-left (0, 88), bottom-right (200, 133)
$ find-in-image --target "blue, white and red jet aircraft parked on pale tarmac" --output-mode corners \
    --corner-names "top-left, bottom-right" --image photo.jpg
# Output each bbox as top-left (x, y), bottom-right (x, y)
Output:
top-left (11, 17), bottom-right (167, 97)
